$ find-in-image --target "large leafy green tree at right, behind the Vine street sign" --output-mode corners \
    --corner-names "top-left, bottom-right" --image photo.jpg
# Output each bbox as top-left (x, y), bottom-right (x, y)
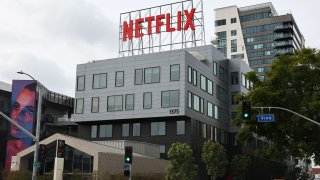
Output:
top-left (234, 49), bottom-right (320, 164)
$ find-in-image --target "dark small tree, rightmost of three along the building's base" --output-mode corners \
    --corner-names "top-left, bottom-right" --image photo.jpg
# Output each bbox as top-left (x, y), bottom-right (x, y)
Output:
top-left (231, 154), bottom-right (251, 179)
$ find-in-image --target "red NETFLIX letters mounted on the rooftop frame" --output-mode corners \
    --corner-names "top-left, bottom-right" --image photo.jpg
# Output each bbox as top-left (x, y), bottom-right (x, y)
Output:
top-left (122, 8), bottom-right (196, 41)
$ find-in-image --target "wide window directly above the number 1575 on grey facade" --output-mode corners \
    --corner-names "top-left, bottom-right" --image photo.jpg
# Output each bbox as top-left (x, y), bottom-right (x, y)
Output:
top-left (161, 90), bottom-right (179, 108)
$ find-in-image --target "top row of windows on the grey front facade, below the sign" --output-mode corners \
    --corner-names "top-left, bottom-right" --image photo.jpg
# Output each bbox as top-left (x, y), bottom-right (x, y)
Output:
top-left (77, 64), bottom-right (180, 91)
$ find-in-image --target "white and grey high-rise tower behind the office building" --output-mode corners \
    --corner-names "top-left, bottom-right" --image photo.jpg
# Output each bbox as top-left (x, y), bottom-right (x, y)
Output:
top-left (213, 3), bottom-right (304, 79)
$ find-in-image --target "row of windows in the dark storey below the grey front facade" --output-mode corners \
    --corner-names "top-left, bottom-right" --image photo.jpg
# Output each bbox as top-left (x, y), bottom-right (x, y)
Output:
top-left (91, 120), bottom-right (186, 138)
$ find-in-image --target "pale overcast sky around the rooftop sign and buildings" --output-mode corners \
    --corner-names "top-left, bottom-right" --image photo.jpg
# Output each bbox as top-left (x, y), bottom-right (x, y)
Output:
top-left (0, 0), bottom-right (320, 96)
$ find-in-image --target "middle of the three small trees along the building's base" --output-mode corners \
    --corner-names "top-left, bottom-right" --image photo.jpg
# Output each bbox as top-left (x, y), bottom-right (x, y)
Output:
top-left (201, 139), bottom-right (228, 180)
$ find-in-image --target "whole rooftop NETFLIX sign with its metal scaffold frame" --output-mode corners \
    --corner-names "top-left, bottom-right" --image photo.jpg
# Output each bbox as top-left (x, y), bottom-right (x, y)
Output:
top-left (119, 0), bottom-right (205, 57)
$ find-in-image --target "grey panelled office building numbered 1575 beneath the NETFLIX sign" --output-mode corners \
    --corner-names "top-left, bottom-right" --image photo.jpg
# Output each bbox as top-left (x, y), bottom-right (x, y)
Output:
top-left (73, 45), bottom-right (252, 158)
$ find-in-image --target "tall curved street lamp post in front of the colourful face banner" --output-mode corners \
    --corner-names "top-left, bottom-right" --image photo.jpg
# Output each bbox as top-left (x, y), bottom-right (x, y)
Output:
top-left (17, 71), bottom-right (42, 180)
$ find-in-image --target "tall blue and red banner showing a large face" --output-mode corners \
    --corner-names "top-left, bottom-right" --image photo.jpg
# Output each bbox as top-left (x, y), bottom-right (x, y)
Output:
top-left (6, 80), bottom-right (37, 171)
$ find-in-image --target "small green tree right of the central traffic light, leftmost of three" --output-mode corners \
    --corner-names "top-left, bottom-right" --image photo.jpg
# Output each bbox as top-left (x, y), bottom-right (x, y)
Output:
top-left (166, 142), bottom-right (198, 180)
